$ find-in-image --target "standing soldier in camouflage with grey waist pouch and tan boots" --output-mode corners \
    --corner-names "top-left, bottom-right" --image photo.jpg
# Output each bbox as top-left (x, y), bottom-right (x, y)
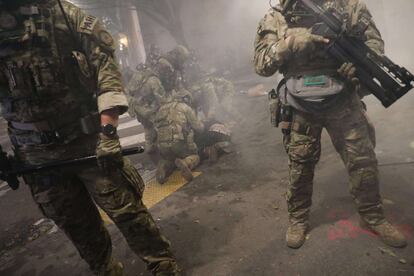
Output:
top-left (254, 0), bottom-right (407, 248)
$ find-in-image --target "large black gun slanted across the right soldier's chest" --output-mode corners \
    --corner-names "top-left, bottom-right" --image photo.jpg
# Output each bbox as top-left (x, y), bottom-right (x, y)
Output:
top-left (281, 0), bottom-right (414, 108)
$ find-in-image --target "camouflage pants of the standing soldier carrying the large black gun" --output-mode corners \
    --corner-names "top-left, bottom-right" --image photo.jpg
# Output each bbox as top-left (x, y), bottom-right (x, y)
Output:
top-left (284, 100), bottom-right (384, 224)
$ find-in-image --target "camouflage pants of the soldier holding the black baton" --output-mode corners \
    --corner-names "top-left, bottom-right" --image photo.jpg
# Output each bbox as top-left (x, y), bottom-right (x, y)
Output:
top-left (25, 156), bottom-right (176, 275)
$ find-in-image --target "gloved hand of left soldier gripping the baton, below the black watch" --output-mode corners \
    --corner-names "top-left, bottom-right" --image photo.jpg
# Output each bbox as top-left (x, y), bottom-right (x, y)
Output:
top-left (96, 134), bottom-right (124, 173)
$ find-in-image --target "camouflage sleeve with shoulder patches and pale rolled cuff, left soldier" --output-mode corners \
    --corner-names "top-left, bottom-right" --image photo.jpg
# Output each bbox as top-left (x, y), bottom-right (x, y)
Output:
top-left (63, 1), bottom-right (128, 114)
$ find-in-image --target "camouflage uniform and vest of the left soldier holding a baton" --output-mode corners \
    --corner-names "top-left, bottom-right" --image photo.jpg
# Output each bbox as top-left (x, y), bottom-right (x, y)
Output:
top-left (0, 0), bottom-right (178, 275)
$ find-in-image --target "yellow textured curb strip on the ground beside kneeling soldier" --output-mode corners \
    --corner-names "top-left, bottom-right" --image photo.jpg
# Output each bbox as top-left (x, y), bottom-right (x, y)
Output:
top-left (99, 171), bottom-right (201, 224)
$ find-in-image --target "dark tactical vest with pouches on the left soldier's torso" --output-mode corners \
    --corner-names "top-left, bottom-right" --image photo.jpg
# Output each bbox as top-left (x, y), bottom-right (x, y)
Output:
top-left (0, 1), bottom-right (98, 147)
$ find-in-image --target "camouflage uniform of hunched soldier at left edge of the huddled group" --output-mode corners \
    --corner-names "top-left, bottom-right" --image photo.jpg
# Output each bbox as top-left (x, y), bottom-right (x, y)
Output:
top-left (126, 69), bottom-right (167, 154)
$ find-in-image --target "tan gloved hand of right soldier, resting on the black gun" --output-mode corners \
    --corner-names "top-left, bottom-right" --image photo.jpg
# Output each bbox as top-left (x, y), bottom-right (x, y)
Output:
top-left (286, 29), bottom-right (329, 55)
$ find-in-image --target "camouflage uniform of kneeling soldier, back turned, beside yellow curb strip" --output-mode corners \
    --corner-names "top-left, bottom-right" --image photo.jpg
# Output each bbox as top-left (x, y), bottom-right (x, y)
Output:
top-left (155, 92), bottom-right (204, 183)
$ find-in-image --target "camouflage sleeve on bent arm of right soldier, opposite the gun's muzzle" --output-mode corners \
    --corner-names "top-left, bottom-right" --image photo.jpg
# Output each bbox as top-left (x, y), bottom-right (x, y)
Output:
top-left (254, 9), bottom-right (291, 77)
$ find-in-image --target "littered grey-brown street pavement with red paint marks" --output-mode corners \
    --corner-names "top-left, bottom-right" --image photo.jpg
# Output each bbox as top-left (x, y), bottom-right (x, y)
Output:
top-left (0, 78), bottom-right (414, 276)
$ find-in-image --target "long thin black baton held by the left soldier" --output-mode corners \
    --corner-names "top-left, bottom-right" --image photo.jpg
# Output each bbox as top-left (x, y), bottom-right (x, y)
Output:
top-left (0, 146), bottom-right (144, 190)
